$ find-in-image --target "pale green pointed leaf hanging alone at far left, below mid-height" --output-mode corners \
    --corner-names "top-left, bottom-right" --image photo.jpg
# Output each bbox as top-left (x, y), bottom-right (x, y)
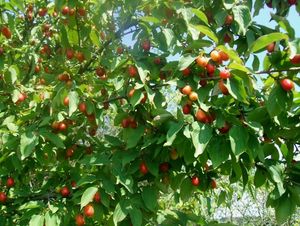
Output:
top-left (20, 130), bottom-right (39, 160)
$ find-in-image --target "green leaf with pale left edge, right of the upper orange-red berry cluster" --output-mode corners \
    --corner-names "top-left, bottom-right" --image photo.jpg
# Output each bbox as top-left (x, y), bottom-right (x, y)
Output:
top-left (226, 76), bottom-right (249, 104)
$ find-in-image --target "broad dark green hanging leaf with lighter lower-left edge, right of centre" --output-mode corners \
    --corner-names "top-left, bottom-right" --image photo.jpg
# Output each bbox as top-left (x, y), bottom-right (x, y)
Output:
top-left (229, 125), bottom-right (249, 155)
